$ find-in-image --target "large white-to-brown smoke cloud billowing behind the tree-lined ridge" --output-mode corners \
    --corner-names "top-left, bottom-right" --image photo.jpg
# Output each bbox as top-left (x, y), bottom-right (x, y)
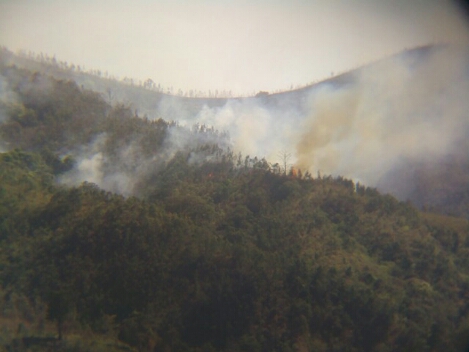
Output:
top-left (158, 45), bottom-right (469, 199)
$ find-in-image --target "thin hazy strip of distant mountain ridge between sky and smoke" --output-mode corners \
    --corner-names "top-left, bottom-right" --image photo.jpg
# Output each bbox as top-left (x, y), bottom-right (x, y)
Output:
top-left (0, 45), bottom-right (440, 120)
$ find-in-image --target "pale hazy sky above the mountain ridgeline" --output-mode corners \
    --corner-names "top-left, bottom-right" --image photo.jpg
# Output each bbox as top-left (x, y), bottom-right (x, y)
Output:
top-left (0, 0), bottom-right (469, 94)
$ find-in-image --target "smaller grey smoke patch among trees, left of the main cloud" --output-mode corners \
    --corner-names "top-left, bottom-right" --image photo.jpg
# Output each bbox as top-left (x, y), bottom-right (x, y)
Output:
top-left (58, 125), bottom-right (226, 196)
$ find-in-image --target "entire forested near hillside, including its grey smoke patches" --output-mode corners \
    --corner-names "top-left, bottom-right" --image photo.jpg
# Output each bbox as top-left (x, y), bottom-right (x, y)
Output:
top-left (0, 56), bottom-right (469, 352)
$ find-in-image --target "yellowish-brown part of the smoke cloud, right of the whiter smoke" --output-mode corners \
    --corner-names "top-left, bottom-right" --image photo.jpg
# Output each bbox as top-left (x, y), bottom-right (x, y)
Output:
top-left (296, 48), bottom-right (469, 193)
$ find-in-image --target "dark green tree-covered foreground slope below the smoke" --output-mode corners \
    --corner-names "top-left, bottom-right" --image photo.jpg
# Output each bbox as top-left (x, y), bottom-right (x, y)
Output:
top-left (1, 152), bottom-right (469, 351)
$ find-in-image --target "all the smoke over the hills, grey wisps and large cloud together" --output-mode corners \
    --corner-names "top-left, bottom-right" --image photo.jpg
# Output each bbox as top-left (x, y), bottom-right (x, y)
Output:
top-left (0, 45), bottom-right (469, 204)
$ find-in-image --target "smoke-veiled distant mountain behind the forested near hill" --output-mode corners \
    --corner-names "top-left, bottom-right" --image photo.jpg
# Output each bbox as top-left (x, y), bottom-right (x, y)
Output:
top-left (0, 44), bottom-right (469, 217)
